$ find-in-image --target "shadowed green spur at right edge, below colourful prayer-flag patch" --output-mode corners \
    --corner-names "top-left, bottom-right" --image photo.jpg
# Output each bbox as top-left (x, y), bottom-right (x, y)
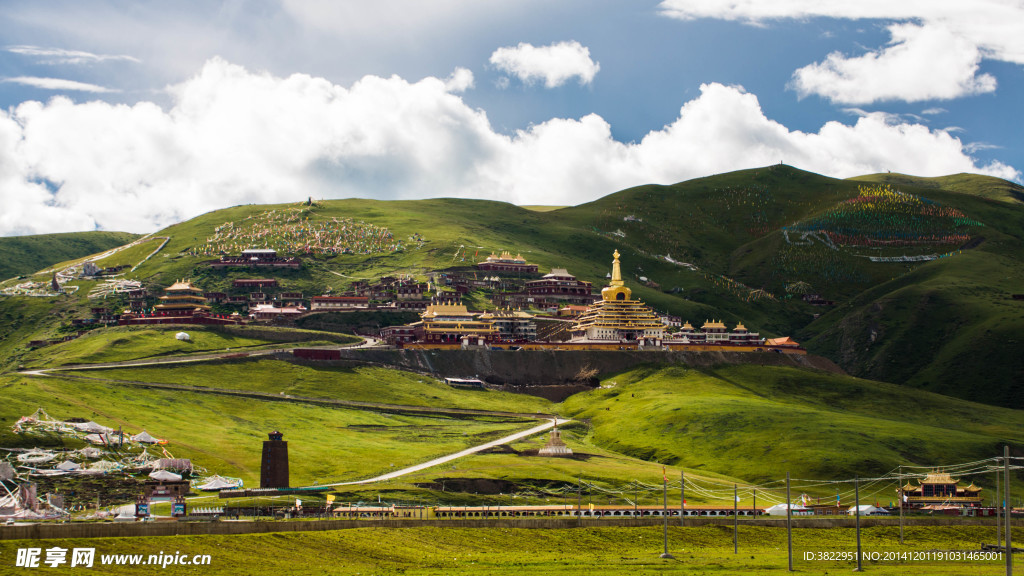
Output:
top-left (798, 188), bottom-right (1024, 408)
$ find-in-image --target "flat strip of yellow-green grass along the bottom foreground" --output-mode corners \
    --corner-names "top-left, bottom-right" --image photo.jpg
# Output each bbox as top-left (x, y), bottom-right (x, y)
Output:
top-left (0, 526), bottom-right (1024, 576)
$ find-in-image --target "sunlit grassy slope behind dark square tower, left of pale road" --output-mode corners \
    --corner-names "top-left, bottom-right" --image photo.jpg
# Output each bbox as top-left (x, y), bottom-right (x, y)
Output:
top-left (0, 368), bottom-right (531, 486)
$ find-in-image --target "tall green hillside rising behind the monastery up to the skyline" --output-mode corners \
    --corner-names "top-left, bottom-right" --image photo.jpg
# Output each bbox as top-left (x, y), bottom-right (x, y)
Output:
top-left (0, 165), bottom-right (1024, 406)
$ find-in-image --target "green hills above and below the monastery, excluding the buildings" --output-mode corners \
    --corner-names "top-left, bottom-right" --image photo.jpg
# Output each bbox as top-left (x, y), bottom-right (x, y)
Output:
top-left (0, 165), bottom-right (1024, 500)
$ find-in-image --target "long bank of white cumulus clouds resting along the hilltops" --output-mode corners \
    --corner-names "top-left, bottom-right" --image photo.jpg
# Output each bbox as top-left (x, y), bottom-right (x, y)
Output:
top-left (0, 59), bottom-right (1020, 235)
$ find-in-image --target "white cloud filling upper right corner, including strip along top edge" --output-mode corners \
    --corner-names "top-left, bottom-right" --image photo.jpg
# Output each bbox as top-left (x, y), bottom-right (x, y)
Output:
top-left (659, 0), bottom-right (1024, 104)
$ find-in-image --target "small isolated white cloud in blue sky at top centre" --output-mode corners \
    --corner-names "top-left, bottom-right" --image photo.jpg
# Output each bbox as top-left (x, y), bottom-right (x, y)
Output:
top-left (490, 40), bottom-right (601, 88)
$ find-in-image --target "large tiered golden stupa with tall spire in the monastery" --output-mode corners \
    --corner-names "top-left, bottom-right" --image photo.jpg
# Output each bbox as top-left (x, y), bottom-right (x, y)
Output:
top-left (571, 250), bottom-right (665, 343)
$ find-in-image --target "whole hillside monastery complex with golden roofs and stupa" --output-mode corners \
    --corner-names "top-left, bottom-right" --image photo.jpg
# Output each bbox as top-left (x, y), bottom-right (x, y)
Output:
top-left (61, 242), bottom-right (806, 354)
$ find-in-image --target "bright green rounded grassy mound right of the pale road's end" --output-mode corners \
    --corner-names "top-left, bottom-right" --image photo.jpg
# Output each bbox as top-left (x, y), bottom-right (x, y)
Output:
top-left (563, 366), bottom-right (1024, 481)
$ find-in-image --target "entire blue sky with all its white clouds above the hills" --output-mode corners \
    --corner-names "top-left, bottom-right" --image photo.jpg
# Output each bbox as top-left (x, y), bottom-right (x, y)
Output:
top-left (0, 0), bottom-right (1024, 235)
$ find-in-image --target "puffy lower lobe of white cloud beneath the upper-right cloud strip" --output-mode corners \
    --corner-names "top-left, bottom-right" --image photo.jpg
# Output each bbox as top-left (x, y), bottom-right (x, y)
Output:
top-left (792, 24), bottom-right (995, 104)
